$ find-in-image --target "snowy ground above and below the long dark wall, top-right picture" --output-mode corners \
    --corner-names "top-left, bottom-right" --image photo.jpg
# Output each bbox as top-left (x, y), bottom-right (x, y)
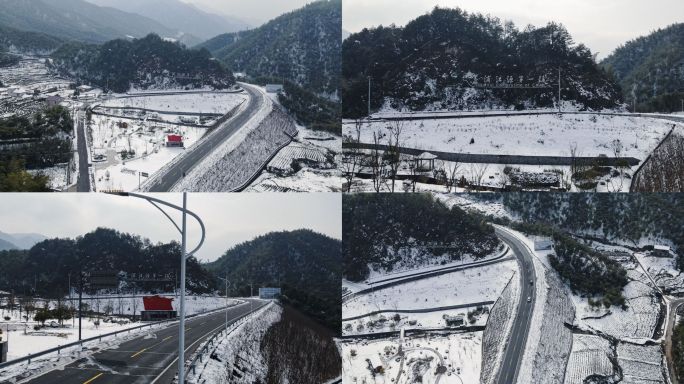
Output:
top-left (343, 114), bottom-right (684, 192)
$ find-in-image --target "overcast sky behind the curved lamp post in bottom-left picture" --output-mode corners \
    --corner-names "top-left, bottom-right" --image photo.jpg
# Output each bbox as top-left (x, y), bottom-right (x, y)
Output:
top-left (0, 193), bottom-right (342, 261)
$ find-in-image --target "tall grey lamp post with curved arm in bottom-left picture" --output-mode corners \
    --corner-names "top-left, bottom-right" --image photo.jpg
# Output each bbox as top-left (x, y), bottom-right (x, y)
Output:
top-left (107, 192), bottom-right (206, 384)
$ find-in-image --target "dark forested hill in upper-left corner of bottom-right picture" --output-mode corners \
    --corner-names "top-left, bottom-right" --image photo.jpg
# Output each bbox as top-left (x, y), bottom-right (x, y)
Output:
top-left (342, 194), bottom-right (500, 281)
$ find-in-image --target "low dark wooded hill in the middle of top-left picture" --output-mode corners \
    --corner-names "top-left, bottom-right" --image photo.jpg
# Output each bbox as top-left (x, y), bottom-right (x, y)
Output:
top-left (50, 34), bottom-right (235, 92)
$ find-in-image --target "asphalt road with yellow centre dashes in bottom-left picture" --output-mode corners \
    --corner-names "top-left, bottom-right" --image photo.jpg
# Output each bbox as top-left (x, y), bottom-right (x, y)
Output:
top-left (28, 299), bottom-right (267, 384)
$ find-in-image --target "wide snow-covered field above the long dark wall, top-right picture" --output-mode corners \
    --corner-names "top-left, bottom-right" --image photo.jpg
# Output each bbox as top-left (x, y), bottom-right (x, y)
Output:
top-left (343, 114), bottom-right (673, 159)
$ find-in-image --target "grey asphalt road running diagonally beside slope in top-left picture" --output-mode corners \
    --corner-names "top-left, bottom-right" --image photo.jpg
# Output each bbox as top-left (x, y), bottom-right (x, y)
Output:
top-left (147, 84), bottom-right (264, 192)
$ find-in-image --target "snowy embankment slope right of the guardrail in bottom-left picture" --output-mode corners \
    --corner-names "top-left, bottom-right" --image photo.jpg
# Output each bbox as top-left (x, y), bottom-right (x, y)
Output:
top-left (187, 303), bottom-right (282, 384)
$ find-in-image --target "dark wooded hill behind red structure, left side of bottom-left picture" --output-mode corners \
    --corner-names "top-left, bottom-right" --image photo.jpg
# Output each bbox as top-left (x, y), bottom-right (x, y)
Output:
top-left (0, 228), bottom-right (216, 297)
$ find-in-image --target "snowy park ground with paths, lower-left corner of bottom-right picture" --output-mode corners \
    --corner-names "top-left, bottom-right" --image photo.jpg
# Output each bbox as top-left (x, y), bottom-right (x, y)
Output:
top-left (341, 332), bottom-right (482, 384)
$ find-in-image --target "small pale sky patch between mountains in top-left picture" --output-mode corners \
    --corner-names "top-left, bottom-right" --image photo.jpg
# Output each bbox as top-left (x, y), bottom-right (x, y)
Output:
top-left (182, 0), bottom-right (312, 26)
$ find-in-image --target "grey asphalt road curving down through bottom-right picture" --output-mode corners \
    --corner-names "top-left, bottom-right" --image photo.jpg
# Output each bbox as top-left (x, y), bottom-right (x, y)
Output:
top-left (496, 228), bottom-right (537, 384)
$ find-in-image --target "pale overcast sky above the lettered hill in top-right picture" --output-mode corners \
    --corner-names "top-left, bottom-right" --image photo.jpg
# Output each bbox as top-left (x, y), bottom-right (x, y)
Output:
top-left (342, 0), bottom-right (684, 58)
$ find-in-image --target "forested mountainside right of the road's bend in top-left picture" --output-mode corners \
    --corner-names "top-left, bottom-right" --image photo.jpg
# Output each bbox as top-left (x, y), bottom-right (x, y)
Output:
top-left (199, 0), bottom-right (342, 97)
